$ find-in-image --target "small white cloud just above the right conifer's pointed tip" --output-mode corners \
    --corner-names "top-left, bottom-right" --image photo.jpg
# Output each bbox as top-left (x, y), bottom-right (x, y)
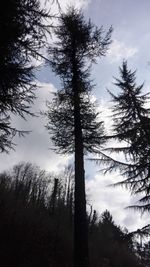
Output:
top-left (107, 39), bottom-right (138, 63)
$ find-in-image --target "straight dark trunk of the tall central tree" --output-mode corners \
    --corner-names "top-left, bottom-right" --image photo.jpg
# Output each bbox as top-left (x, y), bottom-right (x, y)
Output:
top-left (74, 81), bottom-right (89, 267)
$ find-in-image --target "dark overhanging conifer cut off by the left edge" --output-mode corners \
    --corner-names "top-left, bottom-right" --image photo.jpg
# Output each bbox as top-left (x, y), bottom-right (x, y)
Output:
top-left (0, 0), bottom-right (50, 152)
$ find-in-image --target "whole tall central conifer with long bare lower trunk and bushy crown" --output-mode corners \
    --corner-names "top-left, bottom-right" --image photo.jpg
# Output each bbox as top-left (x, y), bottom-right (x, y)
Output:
top-left (46, 8), bottom-right (112, 267)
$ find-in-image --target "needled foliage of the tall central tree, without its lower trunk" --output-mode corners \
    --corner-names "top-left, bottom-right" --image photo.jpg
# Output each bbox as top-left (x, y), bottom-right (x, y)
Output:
top-left (46, 8), bottom-right (112, 153)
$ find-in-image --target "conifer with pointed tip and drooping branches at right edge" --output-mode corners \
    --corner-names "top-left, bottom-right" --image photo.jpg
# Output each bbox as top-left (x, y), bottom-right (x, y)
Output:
top-left (95, 61), bottom-right (150, 214)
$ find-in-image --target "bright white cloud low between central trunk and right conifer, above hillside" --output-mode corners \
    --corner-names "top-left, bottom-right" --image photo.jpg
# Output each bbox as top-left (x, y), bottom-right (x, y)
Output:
top-left (86, 173), bottom-right (149, 231)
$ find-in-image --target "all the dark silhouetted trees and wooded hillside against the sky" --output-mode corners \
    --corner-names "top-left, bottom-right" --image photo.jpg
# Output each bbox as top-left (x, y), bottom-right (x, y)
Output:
top-left (0, 0), bottom-right (150, 267)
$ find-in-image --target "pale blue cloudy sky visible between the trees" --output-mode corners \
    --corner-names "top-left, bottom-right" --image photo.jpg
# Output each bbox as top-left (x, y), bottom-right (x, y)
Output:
top-left (0, 0), bottom-right (150, 231)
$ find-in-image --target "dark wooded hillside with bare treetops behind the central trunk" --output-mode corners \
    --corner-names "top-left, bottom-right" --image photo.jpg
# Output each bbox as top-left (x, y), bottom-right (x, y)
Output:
top-left (0, 163), bottom-right (149, 267)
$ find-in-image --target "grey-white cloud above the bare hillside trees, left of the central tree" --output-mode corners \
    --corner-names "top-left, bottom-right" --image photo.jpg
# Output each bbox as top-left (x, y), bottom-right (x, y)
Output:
top-left (0, 83), bottom-right (68, 174)
